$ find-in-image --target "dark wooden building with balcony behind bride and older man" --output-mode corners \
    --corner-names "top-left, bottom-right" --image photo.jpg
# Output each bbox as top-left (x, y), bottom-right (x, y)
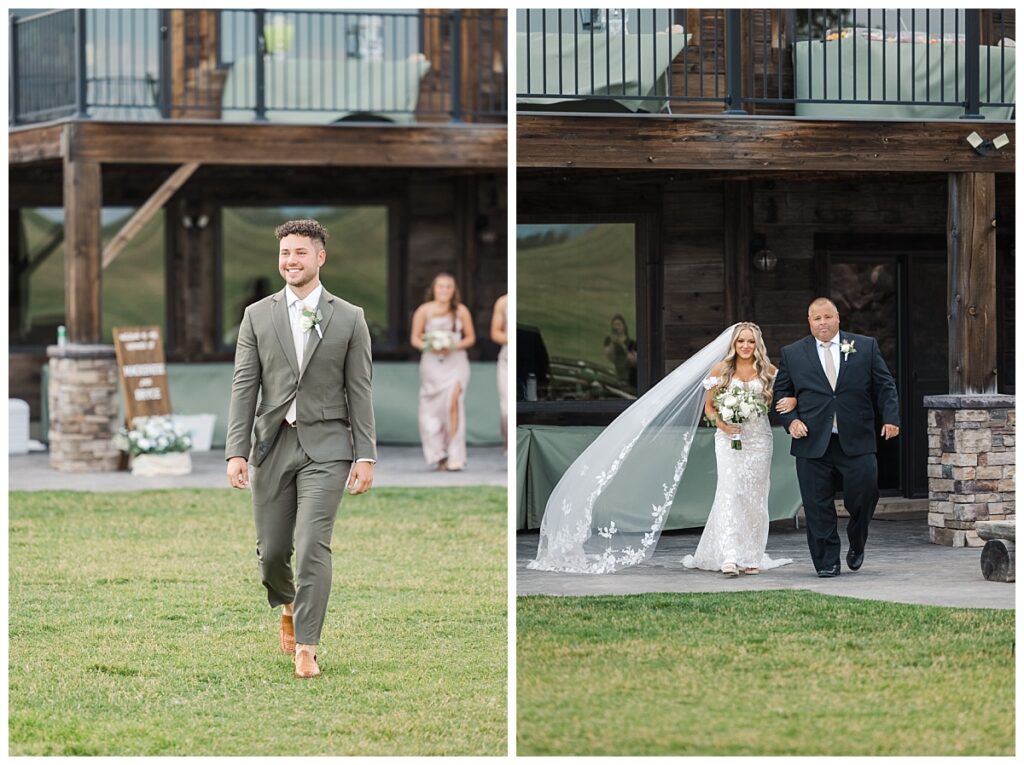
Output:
top-left (516, 9), bottom-right (1016, 507)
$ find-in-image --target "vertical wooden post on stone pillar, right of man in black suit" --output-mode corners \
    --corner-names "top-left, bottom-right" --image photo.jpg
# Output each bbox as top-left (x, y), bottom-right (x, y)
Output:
top-left (946, 173), bottom-right (998, 394)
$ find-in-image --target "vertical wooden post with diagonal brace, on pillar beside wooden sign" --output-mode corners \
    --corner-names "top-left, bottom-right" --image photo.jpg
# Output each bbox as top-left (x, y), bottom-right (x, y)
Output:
top-left (63, 157), bottom-right (103, 344)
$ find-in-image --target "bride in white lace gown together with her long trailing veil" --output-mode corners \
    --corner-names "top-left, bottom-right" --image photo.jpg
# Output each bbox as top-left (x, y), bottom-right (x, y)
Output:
top-left (526, 323), bottom-right (796, 573)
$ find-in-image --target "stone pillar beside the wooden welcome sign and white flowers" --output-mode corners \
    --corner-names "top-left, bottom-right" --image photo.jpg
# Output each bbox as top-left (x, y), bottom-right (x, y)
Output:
top-left (46, 344), bottom-right (121, 473)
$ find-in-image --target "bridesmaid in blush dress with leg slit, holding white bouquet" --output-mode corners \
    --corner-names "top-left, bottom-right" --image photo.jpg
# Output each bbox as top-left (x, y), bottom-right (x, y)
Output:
top-left (410, 273), bottom-right (476, 470)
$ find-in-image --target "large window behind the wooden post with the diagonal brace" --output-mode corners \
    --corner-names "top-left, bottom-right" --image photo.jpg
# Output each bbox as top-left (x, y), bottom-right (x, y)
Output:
top-left (10, 207), bottom-right (165, 345)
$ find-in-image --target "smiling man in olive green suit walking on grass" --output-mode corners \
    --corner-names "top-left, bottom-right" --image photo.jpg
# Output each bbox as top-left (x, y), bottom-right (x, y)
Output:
top-left (224, 220), bottom-right (377, 678)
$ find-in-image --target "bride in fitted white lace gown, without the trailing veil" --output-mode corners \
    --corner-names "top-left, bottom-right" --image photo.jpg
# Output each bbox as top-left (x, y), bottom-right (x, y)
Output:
top-left (683, 323), bottom-right (796, 577)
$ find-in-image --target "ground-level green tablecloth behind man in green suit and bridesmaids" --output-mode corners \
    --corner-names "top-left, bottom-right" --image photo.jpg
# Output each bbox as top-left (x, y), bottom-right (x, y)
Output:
top-left (41, 362), bottom-right (502, 449)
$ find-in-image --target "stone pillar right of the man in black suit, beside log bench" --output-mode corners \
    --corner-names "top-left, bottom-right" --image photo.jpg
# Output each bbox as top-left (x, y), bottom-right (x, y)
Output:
top-left (925, 394), bottom-right (1017, 547)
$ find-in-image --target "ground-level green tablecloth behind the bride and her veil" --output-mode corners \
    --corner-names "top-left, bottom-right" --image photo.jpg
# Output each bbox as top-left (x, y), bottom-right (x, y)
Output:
top-left (516, 425), bottom-right (802, 529)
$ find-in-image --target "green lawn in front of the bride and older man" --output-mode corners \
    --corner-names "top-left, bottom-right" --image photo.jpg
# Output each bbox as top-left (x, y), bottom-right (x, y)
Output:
top-left (516, 591), bottom-right (1015, 756)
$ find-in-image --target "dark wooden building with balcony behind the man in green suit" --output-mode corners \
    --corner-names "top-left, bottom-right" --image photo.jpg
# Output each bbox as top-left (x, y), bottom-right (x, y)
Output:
top-left (8, 9), bottom-right (507, 439)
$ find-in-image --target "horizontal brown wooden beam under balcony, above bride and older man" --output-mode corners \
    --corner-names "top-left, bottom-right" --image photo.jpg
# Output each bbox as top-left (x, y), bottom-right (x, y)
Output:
top-left (516, 115), bottom-right (1016, 173)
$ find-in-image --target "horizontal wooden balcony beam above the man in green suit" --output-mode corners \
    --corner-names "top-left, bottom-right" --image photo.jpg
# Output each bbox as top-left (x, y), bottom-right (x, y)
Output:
top-left (72, 121), bottom-right (508, 169)
